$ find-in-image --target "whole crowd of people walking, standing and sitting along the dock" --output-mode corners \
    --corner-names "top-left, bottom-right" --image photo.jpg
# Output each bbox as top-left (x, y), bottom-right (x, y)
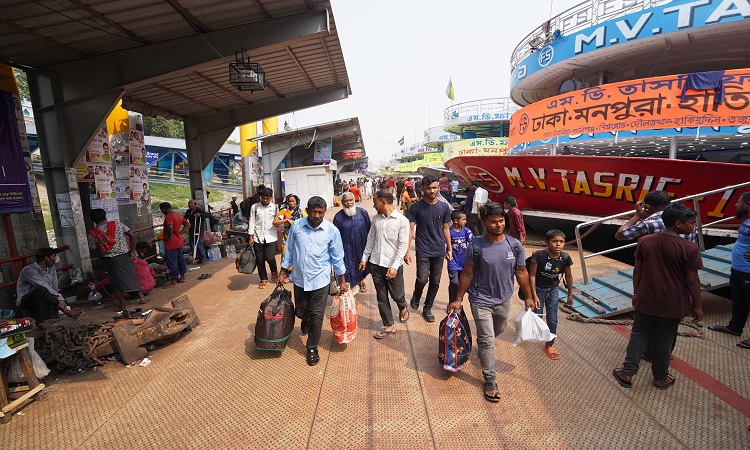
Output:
top-left (17, 171), bottom-right (750, 402)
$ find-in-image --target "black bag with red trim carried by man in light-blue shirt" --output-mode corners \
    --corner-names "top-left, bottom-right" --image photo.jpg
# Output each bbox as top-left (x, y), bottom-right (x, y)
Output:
top-left (254, 286), bottom-right (294, 352)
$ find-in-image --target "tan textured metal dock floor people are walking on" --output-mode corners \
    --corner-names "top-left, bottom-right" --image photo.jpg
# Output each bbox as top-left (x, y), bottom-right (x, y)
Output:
top-left (0, 199), bottom-right (750, 450)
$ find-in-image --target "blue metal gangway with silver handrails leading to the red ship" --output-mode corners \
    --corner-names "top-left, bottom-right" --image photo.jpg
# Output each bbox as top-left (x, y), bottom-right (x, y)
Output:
top-left (560, 182), bottom-right (750, 318)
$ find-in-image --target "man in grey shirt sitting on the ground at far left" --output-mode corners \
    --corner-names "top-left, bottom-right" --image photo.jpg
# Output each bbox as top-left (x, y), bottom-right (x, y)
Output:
top-left (16, 247), bottom-right (83, 323)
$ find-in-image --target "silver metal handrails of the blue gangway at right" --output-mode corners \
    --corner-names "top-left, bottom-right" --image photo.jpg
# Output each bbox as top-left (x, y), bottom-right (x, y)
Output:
top-left (575, 182), bottom-right (750, 284)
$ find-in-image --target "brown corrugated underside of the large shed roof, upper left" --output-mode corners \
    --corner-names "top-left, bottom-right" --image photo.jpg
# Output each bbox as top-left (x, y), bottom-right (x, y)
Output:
top-left (0, 0), bottom-right (350, 118)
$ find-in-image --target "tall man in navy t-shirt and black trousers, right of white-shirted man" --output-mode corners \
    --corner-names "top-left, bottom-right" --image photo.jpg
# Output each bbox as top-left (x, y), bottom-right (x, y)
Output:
top-left (405, 175), bottom-right (453, 322)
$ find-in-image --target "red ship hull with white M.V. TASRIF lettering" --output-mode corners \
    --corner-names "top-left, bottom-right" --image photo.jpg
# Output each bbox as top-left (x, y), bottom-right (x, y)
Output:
top-left (445, 155), bottom-right (748, 223)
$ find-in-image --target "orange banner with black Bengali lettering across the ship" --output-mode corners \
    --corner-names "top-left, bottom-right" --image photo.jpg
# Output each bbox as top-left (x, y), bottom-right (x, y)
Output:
top-left (512, 69), bottom-right (750, 147)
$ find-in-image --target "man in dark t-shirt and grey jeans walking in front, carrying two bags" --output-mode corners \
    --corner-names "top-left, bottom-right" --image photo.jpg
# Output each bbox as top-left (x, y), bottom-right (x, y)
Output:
top-left (447, 202), bottom-right (538, 403)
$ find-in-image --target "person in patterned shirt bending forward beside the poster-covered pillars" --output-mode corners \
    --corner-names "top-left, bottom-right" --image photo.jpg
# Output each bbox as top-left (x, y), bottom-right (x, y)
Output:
top-left (88, 208), bottom-right (148, 309)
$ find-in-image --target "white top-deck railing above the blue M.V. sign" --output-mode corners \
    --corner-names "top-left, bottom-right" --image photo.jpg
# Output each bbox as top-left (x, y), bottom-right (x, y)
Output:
top-left (510, 0), bottom-right (672, 70)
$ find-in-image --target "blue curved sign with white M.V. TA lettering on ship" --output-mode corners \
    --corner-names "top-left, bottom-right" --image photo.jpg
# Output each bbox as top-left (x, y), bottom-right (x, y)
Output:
top-left (511, 0), bottom-right (750, 88)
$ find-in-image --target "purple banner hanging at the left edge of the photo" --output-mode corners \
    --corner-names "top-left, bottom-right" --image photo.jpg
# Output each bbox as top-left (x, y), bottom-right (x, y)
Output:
top-left (0, 91), bottom-right (34, 214)
